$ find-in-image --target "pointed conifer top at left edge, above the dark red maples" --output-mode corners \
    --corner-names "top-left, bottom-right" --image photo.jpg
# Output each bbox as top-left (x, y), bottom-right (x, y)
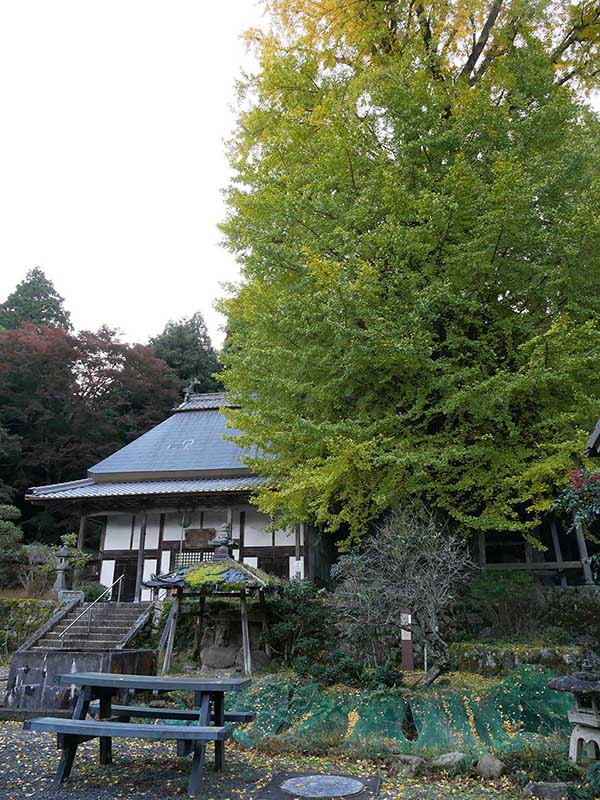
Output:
top-left (0, 267), bottom-right (72, 330)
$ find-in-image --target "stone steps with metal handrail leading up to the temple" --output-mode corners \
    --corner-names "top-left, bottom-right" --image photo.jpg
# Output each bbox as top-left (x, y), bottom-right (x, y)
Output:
top-left (29, 602), bottom-right (153, 652)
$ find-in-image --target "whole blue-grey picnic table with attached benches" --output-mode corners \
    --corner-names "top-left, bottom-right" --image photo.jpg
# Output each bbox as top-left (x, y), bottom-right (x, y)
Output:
top-left (23, 672), bottom-right (254, 796)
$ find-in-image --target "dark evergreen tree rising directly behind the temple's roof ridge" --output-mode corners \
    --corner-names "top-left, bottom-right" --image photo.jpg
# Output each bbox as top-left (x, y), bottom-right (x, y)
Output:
top-left (150, 311), bottom-right (222, 392)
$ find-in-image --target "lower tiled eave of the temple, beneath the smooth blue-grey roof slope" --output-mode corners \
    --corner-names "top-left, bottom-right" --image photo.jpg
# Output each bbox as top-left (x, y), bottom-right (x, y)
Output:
top-left (27, 475), bottom-right (266, 500)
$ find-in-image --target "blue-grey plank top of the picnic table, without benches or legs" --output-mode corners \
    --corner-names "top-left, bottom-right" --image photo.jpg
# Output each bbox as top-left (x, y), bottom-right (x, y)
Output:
top-left (54, 672), bottom-right (252, 692)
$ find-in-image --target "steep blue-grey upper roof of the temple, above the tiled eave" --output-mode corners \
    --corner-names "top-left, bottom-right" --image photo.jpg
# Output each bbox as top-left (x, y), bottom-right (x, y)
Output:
top-left (88, 394), bottom-right (246, 477)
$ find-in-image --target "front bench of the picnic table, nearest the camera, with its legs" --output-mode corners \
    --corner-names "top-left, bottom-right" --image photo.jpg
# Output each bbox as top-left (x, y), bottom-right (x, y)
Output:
top-left (23, 707), bottom-right (231, 795)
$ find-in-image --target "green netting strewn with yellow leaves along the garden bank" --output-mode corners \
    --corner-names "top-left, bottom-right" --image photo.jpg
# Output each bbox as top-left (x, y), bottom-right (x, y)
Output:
top-left (232, 666), bottom-right (572, 753)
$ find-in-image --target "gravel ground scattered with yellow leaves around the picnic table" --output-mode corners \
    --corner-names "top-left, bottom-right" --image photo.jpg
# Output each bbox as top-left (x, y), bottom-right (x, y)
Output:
top-left (0, 722), bottom-right (520, 800)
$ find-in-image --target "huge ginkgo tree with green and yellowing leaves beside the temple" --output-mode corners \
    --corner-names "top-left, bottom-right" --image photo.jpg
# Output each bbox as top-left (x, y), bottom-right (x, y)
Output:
top-left (224, 0), bottom-right (600, 537)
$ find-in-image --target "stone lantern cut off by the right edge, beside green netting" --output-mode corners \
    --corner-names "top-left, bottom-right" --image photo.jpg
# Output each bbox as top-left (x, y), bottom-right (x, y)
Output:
top-left (548, 651), bottom-right (600, 764)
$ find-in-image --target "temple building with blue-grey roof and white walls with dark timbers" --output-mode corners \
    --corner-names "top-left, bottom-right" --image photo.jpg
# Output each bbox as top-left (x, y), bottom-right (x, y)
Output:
top-left (27, 392), bottom-right (331, 600)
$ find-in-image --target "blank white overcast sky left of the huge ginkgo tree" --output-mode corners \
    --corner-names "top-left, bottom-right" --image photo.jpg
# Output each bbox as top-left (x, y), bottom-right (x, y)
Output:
top-left (0, 0), bottom-right (262, 344)
